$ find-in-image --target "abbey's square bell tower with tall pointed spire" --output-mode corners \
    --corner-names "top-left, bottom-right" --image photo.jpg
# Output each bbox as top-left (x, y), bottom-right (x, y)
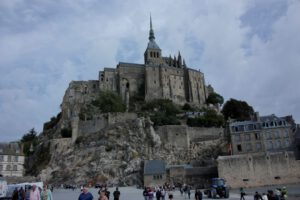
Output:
top-left (144, 15), bottom-right (161, 65)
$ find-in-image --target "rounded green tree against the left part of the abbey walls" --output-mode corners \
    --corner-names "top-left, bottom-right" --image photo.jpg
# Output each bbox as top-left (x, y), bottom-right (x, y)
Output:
top-left (92, 91), bottom-right (126, 113)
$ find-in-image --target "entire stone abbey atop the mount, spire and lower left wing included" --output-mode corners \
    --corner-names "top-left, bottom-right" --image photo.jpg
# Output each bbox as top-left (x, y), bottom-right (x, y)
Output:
top-left (61, 17), bottom-right (213, 122)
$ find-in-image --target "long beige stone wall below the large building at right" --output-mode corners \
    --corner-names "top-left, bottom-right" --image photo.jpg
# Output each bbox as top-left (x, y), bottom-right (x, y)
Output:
top-left (217, 152), bottom-right (300, 188)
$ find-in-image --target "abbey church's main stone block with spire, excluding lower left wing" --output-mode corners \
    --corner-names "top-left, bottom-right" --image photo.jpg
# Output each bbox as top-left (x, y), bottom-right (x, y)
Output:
top-left (99, 17), bottom-right (211, 106)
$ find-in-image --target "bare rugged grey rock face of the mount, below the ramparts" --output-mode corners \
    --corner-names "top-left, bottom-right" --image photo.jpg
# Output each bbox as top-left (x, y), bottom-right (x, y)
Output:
top-left (36, 115), bottom-right (224, 185)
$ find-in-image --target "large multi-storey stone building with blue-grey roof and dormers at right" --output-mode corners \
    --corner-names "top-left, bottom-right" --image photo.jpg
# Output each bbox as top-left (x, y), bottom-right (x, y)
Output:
top-left (228, 113), bottom-right (295, 155)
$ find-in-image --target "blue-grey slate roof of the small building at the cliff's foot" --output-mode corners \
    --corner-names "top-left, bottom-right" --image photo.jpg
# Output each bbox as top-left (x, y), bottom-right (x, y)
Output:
top-left (144, 160), bottom-right (166, 175)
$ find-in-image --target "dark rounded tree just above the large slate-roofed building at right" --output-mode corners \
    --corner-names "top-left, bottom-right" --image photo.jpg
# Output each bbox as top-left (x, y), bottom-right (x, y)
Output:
top-left (221, 99), bottom-right (254, 121)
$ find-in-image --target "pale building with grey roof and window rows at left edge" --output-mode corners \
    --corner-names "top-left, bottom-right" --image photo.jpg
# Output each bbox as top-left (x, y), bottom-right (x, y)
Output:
top-left (0, 143), bottom-right (25, 176)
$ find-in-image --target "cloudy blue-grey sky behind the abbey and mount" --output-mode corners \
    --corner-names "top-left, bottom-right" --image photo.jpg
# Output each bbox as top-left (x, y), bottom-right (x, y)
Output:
top-left (0, 0), bottom-right (300, 141)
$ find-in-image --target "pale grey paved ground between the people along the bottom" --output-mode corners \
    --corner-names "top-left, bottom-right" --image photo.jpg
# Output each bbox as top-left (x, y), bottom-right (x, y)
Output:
top-left (53, 184), bottom-right (300, 200)
